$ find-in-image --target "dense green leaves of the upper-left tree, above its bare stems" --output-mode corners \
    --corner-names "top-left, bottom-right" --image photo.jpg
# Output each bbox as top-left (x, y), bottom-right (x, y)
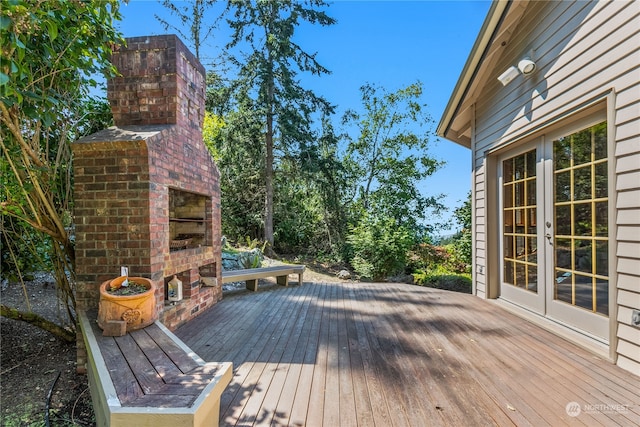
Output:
top-left (0, 0), bottom-right (121, 119)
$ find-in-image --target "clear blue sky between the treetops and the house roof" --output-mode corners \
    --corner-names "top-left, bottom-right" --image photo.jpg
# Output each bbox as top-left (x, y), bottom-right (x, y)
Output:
top-left (112, 0), bottom-right (490, 234)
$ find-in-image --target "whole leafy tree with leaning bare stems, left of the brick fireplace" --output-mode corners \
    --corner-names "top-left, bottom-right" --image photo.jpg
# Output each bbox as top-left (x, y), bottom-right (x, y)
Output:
top-left (0, 0), bottom-right (123, 336)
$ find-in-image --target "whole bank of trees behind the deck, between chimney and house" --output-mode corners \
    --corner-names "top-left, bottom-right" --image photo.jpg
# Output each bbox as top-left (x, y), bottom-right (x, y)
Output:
top-left (205, 5), bottom-right (456, 272)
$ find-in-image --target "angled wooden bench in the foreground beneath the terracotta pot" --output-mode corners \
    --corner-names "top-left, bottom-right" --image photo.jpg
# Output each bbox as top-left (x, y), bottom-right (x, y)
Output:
top-left (79, 313), bottom-right (232, 427)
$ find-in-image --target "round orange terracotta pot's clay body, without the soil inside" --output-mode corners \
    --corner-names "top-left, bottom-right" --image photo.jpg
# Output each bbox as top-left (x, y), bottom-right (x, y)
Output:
top-left (98, 277), bottom-right (158, 332)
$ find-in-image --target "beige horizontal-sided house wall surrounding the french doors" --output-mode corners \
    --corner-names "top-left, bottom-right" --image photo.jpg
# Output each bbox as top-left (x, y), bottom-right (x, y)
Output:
top-left (472, 1), bottom-right (640, 374)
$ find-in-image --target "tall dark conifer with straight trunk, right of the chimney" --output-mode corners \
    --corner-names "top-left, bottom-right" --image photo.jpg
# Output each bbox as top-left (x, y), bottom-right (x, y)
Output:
top-left (227, 0), bottom-right (334, 244)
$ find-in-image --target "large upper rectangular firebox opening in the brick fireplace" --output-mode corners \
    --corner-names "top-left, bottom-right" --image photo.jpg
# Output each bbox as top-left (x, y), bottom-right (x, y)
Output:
top-left (169, 188), bottom-right (212, 252)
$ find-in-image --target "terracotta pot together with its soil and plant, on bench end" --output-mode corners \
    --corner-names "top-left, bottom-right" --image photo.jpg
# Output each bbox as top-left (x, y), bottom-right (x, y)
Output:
top-left (98, 276), bottom-right (158, 335)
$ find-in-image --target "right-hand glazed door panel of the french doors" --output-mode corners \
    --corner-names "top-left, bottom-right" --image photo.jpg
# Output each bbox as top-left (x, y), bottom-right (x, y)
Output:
top-left (549, 122), bottom-right (609, 340)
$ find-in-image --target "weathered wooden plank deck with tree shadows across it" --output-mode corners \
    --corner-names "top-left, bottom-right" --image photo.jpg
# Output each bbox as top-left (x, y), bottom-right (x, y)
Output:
top-left (176, 283), bottom-right (640, 427)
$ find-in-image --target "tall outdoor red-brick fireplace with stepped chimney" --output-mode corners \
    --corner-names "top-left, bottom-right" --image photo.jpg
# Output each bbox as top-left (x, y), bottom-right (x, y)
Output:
top-left (72, 35), bottom-right (222, 350)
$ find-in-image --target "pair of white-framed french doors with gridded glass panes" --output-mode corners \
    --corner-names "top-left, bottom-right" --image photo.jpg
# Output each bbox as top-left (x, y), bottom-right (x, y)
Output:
top-left (499, 118), bottom-right (609, 342)
